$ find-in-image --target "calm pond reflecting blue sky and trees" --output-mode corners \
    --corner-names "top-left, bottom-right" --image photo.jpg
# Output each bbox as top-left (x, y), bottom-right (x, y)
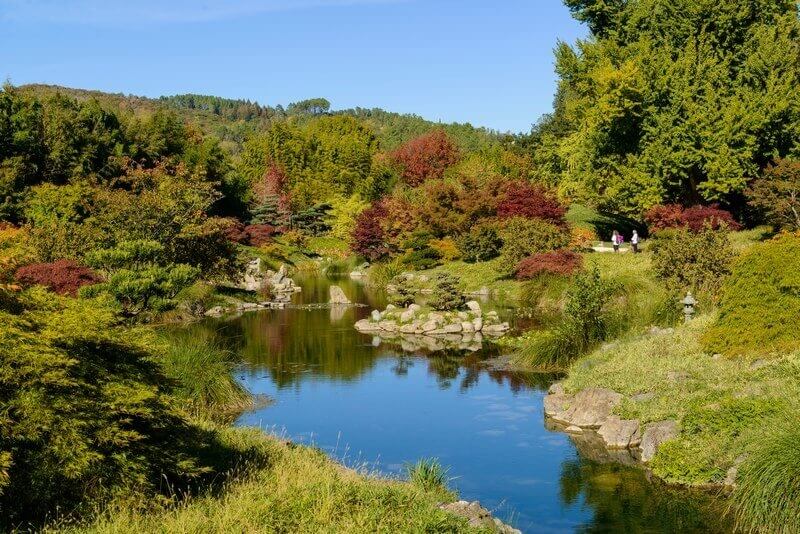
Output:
top-left (183, 277), bottom-right (727, 532)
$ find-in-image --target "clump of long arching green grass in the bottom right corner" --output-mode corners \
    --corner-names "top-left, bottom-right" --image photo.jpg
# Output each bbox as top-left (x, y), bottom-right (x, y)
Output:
top-left (733, 414), bottom-right (800, 534)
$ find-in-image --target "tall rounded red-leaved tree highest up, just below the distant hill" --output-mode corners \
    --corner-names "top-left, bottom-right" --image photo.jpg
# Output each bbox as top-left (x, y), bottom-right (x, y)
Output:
top-left (391, 130), bottom-right (458, 186)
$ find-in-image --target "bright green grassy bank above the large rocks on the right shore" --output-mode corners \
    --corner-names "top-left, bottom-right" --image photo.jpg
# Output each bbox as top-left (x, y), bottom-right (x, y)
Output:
top-left (564, 315), bottom-right (800, 490)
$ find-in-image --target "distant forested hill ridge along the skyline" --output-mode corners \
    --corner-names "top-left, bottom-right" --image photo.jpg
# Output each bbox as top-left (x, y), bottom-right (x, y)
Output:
top-left (18, 84), bottom-right (505, 153)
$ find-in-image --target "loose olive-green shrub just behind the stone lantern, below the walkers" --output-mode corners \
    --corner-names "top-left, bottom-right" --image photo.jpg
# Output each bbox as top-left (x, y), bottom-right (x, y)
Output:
top-left (652, 227), bottom-right (735, 300)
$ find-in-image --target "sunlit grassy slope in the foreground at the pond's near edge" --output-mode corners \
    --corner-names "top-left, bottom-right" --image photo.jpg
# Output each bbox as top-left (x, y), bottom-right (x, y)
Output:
top-left (56, 429), bottom-right (479, 534)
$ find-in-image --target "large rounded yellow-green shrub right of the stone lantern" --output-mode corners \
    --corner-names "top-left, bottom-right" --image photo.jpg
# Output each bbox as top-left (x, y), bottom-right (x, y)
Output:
top-left (703, 235), bottom-right (800, 355)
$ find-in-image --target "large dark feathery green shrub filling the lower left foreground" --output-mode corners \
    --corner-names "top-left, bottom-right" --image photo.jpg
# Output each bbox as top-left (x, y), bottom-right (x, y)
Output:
top-left (0, 289), bottom-right (222, 530)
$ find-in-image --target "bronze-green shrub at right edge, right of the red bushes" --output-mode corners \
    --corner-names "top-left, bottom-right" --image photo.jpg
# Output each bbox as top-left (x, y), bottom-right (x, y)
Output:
top-left (747, 159), bottom-right (800, 230)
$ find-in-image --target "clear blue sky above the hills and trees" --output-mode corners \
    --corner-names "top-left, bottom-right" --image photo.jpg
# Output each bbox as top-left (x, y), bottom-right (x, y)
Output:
top-left (0, 0), bottom-right (587, 132)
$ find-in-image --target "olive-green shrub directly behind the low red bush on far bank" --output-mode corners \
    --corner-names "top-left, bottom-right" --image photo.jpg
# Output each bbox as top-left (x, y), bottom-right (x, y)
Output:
top-left (500, 217), bottom-right (569, 274)
